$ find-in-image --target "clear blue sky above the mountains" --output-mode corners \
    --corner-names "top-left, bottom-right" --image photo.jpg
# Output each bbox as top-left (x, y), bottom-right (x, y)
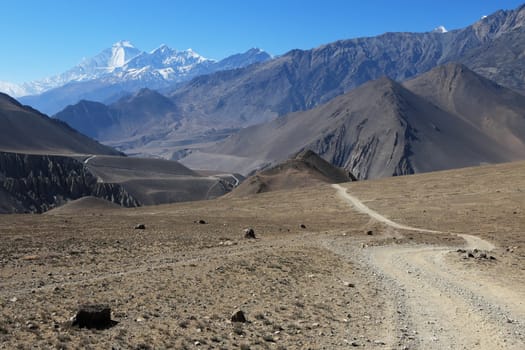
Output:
top-left (0, 0), bottom-right (524, 83)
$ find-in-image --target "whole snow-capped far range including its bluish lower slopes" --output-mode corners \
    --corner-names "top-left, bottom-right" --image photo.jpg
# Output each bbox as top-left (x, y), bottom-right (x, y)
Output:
top-left (0, 41), bottom-right (271, 114)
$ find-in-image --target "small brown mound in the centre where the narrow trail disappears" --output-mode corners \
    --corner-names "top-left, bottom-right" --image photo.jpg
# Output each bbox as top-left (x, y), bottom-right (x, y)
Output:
top-left (228, 150), bottom-right (355, 197)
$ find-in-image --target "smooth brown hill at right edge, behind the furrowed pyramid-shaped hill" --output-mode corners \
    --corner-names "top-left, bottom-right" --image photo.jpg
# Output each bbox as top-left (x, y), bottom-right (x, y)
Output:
top-left (403, 63), bottom-right (525, 159)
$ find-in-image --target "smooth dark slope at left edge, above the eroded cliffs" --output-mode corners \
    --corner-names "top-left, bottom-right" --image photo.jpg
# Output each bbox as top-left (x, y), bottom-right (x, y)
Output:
top-left (0, 93), bottom-right (121, 155)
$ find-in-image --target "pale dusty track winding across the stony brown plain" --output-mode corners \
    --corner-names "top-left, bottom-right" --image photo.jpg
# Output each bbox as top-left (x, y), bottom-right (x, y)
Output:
top-left (333, 185), bottom-right (525, 349)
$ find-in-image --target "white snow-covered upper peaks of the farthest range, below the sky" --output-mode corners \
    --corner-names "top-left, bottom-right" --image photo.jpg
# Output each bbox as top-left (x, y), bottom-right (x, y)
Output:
top-left (4, 40), bottom-right (271, 102)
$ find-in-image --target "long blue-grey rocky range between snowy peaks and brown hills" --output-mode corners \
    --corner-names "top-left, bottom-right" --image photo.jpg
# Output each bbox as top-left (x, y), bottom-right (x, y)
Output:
top-left (57, 6), bottom-right (525, 166)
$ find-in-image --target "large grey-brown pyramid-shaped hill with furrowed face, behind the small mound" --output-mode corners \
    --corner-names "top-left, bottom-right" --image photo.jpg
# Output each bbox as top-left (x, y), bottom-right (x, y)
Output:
top-left (183, 66), bottom-right (525, 179)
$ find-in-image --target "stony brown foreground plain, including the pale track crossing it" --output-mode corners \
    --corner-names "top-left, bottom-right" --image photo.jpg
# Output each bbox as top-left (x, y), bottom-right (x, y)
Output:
top-left (0, 163), bottom-right (525, 349)
